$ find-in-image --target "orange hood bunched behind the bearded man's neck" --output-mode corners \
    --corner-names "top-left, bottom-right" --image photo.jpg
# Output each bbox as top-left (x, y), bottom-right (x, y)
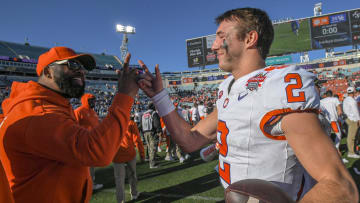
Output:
top-left (2, 81), bottom-right (71, 116)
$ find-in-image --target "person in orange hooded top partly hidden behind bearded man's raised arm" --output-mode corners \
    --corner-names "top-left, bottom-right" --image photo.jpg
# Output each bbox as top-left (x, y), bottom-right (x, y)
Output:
top-left (74, 93), bottom-right (103, 190)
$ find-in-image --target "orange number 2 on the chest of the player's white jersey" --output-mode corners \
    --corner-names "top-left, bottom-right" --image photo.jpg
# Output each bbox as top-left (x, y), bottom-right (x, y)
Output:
top-left (218, 120), bottom-right (230, 184)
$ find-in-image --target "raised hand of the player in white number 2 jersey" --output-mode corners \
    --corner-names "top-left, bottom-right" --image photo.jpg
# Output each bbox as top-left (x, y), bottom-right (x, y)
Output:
top-left (138, 60), bottom-right (164, 98)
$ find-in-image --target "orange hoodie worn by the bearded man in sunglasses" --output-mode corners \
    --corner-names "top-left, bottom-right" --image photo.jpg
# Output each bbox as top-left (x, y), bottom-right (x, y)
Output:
top-left (0, 81), bottom-right (134, 203)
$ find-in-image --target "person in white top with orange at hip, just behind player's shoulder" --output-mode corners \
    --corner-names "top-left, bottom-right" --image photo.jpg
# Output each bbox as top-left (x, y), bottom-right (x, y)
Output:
top-left (320, 90), bottom-right (342, 149)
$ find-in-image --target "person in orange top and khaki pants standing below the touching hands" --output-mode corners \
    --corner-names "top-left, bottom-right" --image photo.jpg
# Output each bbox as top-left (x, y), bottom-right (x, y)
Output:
top-left (113, 115), bottom-right (145, 203)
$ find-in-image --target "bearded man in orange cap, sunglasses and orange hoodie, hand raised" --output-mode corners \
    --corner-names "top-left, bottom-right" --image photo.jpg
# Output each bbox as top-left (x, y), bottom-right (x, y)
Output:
top-left (0, 47), bottom-right (139, 203)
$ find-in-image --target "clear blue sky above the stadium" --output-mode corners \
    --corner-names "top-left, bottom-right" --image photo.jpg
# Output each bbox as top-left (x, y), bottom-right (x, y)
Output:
top-left (0, 0), bottom-right (360, 72)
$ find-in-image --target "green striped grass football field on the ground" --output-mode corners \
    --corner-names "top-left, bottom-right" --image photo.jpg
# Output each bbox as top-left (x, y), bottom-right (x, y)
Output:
top-left (91, 138), bottom-right (360, 203)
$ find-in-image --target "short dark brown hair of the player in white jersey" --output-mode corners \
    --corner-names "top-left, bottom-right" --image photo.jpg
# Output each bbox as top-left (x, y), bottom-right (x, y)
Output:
top-left (215, 8), bottom-right (274, 60)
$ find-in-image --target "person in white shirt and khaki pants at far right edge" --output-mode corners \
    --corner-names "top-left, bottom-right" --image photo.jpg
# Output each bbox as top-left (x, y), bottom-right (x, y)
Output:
top-left (343, 87), bottom-right (360, 159)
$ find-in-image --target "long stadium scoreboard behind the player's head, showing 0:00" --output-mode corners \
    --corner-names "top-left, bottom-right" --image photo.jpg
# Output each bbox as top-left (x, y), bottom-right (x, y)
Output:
top-left (186, 8), bottom-right (360, 67)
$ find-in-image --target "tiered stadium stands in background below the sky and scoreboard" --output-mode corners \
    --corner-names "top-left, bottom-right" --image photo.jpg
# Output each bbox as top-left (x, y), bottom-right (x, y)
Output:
top-left (0, 41), bottom-right (360, 112)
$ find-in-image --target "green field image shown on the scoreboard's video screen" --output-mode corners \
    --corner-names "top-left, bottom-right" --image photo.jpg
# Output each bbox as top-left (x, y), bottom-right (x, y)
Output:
top-left (269, 19), bottom-right (311, 56)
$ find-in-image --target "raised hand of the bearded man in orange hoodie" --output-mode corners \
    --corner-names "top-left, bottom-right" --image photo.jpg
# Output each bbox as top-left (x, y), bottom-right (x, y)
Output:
top-left (116, 53), bottom-right (139, 98)
